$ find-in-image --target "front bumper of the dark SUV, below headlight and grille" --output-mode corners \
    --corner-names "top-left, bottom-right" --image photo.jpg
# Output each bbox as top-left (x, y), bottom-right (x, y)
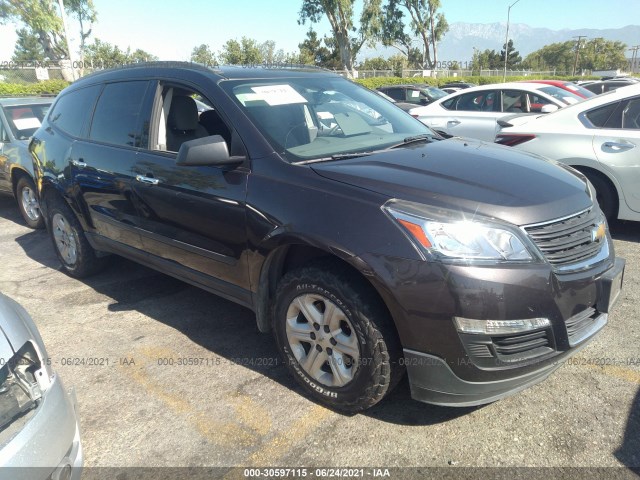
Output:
top-left (360, 245), bottom-right (625, 406)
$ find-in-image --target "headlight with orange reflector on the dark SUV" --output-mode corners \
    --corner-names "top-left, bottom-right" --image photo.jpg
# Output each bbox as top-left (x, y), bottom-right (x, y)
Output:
top-left (383, 200), bottom-right (534, 262)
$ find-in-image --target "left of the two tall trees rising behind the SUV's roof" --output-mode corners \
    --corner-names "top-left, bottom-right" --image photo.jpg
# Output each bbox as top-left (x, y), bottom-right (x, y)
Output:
top-left (298, 0), bottom-right (382, 76)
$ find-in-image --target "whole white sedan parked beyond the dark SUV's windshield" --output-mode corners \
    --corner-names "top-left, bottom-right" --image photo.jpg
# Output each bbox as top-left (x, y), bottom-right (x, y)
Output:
top-left (409, 82), bottom-right (582, 142)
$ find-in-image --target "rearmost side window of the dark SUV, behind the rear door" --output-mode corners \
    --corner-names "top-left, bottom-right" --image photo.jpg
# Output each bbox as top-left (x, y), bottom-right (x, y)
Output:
top-left (49, 85), bottom-right (101, 137)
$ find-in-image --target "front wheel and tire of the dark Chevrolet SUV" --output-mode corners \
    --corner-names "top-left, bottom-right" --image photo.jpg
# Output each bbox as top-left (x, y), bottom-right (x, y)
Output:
top-left (273, 265), bottom-right (404, 413)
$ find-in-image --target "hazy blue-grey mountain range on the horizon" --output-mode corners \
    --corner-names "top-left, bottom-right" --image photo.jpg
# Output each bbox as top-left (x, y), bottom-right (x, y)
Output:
top-left (359, 22), bottom-right (640, 63)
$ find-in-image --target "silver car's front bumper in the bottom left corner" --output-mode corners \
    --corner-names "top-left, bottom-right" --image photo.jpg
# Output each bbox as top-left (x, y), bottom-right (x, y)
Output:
top-left (0, 375), bottom-right (84, 480)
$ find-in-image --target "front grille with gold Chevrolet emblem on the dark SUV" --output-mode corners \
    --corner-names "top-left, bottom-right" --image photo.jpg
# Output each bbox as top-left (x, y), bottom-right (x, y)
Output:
top-left (524, 208), bottom-right (606, 267)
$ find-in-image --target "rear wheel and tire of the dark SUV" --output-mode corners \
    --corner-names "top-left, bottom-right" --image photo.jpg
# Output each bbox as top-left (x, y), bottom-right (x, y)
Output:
top-left (46, 195), bottom-right (106, 278)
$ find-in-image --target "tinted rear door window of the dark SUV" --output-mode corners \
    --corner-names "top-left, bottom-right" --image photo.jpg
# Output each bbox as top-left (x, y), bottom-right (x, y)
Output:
top-left (89, 81), bottom-right (148, 148)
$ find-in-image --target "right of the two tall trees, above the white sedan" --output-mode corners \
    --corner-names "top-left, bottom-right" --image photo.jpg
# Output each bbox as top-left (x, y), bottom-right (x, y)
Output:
top-left (381, 0), bottom-right (449, 68)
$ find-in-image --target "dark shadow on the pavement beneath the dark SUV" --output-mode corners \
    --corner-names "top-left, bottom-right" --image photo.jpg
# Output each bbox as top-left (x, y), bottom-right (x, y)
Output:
top-left (7, 204), bottom-right (474, 425)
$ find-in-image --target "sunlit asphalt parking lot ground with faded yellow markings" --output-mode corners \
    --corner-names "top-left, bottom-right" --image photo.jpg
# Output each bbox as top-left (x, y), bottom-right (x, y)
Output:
top-left (0, 193), bottom-right (640, 480)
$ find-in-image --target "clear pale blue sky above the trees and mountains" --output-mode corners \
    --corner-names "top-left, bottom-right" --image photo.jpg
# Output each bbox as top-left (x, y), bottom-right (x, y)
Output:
top-left (0, 0), bottom-right (640, 61)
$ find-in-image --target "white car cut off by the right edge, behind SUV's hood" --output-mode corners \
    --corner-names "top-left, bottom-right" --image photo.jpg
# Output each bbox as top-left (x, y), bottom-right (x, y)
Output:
top-left (496, 84), bottom-right (640, 221)
